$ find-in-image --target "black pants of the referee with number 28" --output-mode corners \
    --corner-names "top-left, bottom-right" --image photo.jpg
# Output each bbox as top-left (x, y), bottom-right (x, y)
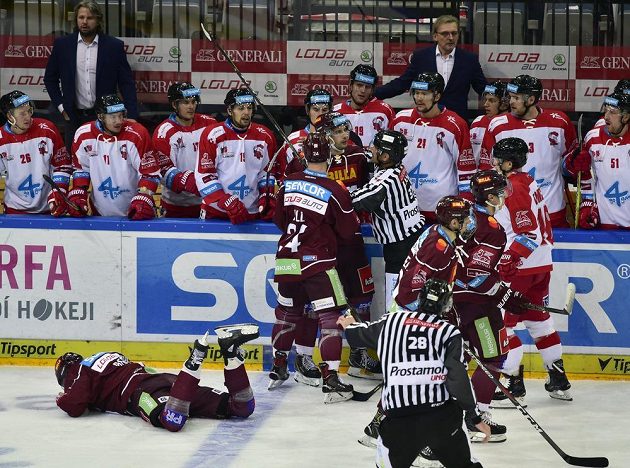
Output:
top-left (379, 401), bottom-right (481, 468)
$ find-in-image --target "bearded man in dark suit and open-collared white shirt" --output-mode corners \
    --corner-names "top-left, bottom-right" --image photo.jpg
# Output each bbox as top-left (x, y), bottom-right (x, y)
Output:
top-left (44, 0), bottom-right (138, 150)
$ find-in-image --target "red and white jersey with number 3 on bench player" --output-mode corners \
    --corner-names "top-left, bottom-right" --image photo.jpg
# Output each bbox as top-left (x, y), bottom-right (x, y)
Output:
top-left (480, 109), bottom-right (578, 220)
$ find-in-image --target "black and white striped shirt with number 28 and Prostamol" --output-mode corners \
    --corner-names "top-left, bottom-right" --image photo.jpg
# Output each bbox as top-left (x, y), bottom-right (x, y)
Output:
top-left (346, 312), bottom-right (476, 417)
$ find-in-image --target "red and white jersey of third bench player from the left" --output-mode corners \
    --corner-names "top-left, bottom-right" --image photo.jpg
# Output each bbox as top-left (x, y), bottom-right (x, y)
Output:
top-left (153, 114), bottom-right (217, 206)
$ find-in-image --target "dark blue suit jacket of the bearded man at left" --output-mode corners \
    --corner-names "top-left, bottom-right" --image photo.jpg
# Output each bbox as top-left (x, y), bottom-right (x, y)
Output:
top-left (44, 32), bottom-right (138, 120)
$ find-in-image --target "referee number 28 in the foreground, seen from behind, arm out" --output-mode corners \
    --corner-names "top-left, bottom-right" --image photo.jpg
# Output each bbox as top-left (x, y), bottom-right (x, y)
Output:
top-left (337, 278), bottom-right (490, 468)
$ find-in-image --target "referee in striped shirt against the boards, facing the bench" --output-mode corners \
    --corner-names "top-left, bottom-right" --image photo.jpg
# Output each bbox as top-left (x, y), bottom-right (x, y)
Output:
top-left (352, 130), bottom-right (424, 310)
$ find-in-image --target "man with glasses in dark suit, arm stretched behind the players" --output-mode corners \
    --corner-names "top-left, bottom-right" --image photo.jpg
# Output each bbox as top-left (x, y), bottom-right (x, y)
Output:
top-left (374, 15), bottom-right (486, 119)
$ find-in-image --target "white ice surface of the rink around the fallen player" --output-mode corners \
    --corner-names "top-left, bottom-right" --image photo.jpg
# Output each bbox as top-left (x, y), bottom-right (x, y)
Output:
top-left (0, 366), bottom-right (630, 468)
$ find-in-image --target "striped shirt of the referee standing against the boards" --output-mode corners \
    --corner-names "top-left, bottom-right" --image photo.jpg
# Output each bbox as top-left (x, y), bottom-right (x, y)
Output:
top-left (352, 164), bottom-right (424, 244)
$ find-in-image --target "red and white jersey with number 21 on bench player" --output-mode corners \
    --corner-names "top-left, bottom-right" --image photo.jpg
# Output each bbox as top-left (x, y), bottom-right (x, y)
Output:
top-left (393, 108), bottom-right (477, 216)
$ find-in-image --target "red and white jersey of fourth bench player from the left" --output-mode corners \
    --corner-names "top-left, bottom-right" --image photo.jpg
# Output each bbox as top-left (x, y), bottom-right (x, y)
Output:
top-left (195, 122), bottom-right (276, 214)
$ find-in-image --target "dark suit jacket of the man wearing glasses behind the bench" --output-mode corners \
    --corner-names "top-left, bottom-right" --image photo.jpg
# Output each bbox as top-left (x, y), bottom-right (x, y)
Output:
top-left (374, 45), bottom-right (486, 118)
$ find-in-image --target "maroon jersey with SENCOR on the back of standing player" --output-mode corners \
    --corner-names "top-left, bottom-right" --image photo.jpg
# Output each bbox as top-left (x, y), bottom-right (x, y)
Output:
top-left (274, 169), bottom-right (359, 282)
